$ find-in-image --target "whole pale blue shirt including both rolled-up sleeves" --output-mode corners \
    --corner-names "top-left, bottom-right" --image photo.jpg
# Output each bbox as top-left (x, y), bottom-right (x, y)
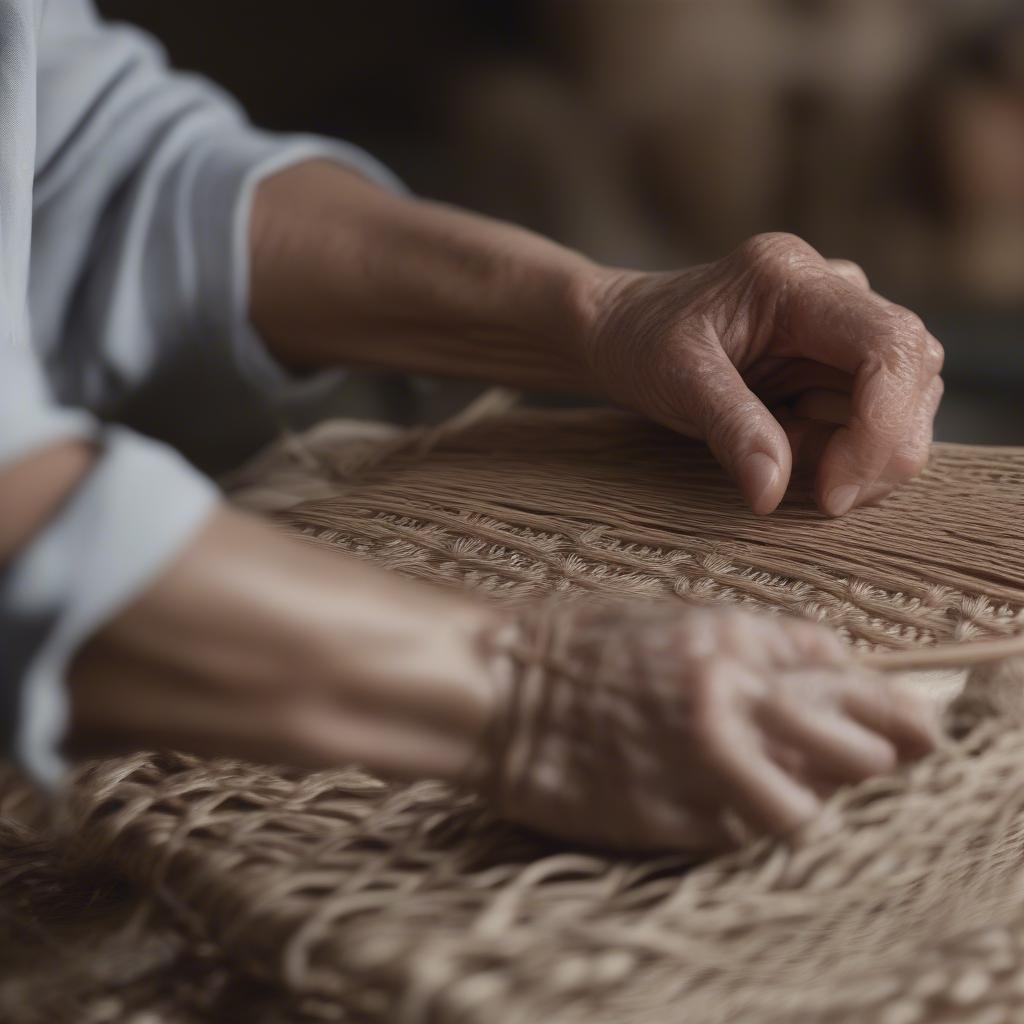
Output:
top-left (0, 0), bottom-right (400, 782)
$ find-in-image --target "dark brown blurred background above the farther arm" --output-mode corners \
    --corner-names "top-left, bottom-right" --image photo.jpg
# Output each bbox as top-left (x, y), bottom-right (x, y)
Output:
top-left (99, 0), bottom-right (1024, 443)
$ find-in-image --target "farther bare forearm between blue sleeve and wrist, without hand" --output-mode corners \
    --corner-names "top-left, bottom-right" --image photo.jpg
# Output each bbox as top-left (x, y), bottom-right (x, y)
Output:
top-left (251, 162), bottom-right (604, 392)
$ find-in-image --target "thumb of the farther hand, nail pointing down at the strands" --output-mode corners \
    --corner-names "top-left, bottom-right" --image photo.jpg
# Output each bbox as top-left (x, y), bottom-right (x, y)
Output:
top-left (688, 349), bottom-right (793, 515)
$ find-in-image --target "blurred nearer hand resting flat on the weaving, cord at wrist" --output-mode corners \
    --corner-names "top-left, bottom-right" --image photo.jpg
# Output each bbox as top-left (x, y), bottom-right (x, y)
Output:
top-left (476, 606), bottom-right (938, 850)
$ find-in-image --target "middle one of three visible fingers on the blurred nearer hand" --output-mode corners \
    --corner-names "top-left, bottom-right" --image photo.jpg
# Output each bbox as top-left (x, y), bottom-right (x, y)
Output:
top-left (759, 702), bottom-right (898, 782)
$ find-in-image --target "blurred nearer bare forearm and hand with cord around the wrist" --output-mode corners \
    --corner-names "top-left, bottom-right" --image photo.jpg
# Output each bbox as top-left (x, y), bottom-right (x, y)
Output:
top-left (70, 501), bottom-right (935, 850)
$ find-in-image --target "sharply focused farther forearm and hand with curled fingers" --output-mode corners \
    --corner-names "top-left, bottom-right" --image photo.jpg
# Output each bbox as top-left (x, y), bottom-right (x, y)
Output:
top-left (250, 162), bottom-right (942, 515)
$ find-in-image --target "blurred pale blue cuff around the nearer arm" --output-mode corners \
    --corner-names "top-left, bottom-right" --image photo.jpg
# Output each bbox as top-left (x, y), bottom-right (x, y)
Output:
top-left (0, 428), bottom-right (219, 786)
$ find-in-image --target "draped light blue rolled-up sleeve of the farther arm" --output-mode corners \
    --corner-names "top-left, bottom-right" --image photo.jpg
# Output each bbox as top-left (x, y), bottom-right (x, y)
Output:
top-left (30, 0), bottom-right (400, 470)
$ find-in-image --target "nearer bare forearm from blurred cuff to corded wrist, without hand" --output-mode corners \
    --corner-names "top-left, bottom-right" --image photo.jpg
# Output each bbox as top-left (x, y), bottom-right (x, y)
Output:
top-left (71, 510), bottom-right (497, 779)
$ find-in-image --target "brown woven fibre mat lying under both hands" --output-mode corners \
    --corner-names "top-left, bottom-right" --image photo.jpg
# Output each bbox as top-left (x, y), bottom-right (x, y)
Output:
top-left (6, 413), bottom-right (1024, 1024)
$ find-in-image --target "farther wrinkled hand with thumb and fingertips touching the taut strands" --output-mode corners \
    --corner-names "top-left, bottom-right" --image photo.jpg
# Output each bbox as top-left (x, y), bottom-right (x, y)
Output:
top-left (585, 234), bottom-right (943, 515)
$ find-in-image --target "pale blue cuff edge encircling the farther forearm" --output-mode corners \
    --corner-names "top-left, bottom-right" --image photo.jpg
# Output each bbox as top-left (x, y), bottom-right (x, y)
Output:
top-left (195, 129), bottom-right (406, 414)
